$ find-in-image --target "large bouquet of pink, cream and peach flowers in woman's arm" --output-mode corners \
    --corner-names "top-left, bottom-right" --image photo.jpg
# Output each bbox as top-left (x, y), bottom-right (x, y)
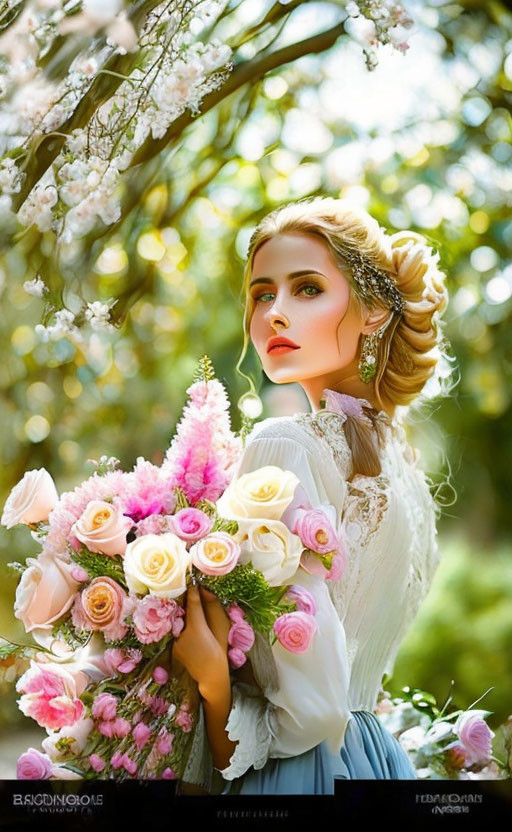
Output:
top-left (0, 356), bottom-right (346, 780)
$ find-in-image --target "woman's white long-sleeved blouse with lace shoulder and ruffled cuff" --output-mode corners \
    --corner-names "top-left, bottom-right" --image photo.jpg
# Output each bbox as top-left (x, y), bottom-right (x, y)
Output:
top-left (215, 410), bottom-right (439, 780)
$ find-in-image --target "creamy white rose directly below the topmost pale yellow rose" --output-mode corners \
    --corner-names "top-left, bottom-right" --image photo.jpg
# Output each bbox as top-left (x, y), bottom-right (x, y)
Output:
top-left (234, 519), bottom-right (304, 586)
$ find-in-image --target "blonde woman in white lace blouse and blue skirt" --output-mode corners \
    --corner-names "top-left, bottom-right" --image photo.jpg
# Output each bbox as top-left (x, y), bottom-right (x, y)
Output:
top-left (174, 198), bottom-right (447, 794)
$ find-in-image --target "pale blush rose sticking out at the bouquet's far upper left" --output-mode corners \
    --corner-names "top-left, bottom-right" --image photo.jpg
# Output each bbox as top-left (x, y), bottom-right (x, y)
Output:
top-left (0, 468), bottom-right (59, 529)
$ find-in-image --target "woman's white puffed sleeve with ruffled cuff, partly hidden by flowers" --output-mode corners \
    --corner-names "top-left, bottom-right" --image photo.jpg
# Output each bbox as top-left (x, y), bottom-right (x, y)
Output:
top-left (213, 426), bottom-right (350, 779)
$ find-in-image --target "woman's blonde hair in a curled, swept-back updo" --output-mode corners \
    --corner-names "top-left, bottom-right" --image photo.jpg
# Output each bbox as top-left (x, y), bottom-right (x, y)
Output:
top-left (235, 197), bottom-right (449, 476)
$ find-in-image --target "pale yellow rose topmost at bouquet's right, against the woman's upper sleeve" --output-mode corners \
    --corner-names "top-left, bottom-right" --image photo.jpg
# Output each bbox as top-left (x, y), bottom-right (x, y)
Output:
top-left (217, 465), bottom-right (300, 521)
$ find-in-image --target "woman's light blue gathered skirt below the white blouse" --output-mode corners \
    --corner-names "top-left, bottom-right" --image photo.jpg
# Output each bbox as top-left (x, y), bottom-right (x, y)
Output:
top-left (221, 711), bottom-right (417, 794)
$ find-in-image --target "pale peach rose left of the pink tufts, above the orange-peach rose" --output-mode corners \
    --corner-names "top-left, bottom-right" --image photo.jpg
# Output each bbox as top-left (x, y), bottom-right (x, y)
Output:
top-left (71, 500), bottom-right (133, 557)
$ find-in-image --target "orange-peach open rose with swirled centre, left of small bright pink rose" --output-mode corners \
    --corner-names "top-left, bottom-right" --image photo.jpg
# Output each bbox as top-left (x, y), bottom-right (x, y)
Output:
top-left (71, 576), bottom-right (136, 641)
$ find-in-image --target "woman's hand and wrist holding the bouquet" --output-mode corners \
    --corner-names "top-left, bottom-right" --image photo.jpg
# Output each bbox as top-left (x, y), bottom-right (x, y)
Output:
top-left (173, 584), bottom-right (231, 699)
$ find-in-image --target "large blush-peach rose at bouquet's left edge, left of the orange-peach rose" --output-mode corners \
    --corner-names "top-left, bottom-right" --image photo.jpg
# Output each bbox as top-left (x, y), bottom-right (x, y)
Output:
top-left (14, 553), bottom-right (79, 633)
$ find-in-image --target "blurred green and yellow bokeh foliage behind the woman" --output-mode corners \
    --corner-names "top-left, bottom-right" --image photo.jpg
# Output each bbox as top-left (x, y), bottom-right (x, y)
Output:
top-left (0, 0), bottom-right (512, 760)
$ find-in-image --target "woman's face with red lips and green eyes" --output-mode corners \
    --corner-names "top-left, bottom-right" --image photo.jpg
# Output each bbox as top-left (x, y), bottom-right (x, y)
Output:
top-left (249, 232), bottom-right (364, 399)
